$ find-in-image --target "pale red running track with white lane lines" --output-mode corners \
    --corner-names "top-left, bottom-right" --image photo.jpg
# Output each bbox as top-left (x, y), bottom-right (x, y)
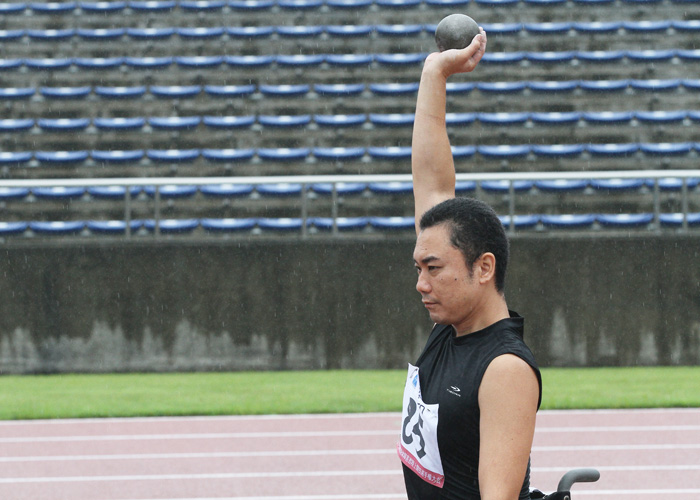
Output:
top-left (0, 409), bottom-right (700, 500)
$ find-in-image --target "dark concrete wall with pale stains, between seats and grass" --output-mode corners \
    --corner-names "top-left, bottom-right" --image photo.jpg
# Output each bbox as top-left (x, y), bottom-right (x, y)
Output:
top-left (0, 235), bottom-right (700, 373)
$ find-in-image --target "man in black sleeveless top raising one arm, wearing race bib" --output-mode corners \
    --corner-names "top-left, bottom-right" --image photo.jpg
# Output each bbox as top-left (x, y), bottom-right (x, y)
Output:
top-left (398, 29), bottom-right (541, 500)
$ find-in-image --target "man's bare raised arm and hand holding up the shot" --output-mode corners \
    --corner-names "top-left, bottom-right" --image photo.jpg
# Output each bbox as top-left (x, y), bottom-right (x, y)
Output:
top-left (411, 29), bottom-right (486, 232)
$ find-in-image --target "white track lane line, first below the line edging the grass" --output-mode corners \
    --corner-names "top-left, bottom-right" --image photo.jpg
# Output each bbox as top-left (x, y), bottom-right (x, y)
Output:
top-left (5, 425), bottom-right (700, 443)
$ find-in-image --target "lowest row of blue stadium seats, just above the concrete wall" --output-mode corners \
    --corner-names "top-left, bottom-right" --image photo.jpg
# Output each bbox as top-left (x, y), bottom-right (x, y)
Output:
top-left (0, 212), bottom-right (700, 237)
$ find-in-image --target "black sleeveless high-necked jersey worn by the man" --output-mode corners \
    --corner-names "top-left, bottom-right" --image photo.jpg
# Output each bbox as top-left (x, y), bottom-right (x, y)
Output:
top-left (403, 311), bottom-right (542, 500)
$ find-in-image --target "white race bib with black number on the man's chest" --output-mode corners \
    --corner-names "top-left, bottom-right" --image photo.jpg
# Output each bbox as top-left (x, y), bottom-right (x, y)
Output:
top-left (397, 363), bottom-right (445, 488)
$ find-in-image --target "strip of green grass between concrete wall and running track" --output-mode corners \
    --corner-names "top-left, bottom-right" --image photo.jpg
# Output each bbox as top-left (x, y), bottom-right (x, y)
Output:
top-left (0, 367), bottom-right (700, 420)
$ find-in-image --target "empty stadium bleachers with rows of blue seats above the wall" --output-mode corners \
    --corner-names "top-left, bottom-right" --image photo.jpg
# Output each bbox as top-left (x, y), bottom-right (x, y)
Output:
top-left (0, 0), bottom-right (700, 236)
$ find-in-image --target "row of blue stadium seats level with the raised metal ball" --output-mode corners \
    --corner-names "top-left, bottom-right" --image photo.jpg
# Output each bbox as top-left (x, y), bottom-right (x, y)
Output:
top-left (0, 20), bottom-right (700, 43)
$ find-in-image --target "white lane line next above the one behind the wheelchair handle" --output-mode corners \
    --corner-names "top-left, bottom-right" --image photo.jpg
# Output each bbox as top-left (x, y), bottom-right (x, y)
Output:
top-left (0, 443), bottom-right (700, 463)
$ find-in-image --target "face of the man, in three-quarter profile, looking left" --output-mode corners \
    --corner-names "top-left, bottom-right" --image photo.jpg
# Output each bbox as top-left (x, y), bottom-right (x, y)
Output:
top-left (413, 224), bottom-right (481, 331)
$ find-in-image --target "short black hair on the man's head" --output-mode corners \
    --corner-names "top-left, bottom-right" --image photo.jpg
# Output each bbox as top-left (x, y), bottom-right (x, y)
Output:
top-left (419, 197), bottom-right (510, 293)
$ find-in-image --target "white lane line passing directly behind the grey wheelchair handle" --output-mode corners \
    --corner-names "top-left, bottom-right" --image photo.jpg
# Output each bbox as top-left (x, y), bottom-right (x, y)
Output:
top-left (0, 464), bottom-right (700, 484)
